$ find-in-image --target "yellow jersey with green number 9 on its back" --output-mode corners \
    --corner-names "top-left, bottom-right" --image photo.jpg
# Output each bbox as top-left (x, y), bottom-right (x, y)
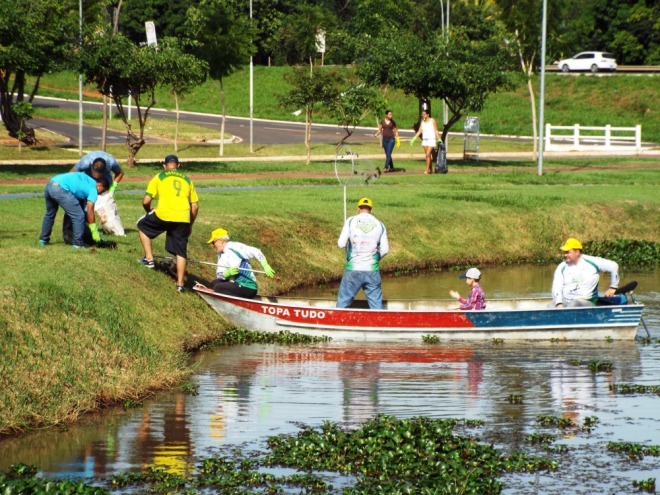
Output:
top-left (146, 170), bottom-right (199, 223)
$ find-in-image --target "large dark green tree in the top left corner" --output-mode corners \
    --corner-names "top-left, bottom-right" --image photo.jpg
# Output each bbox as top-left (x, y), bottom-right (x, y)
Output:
top-left (0, 0), bottom-right (78, 145)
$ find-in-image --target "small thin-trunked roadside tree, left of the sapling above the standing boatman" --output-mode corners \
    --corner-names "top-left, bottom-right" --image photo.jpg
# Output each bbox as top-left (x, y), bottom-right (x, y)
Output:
top-left (279, 67), bottom-right (339, 165)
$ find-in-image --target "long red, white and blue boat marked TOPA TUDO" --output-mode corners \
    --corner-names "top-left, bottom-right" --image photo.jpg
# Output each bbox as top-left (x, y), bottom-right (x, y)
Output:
top-left (193, 284), bottom-right (644, 341)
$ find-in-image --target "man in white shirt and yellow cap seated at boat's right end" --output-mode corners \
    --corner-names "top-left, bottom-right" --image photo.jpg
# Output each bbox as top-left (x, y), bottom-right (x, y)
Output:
top-left (552, 237), bottom-right (619, 308)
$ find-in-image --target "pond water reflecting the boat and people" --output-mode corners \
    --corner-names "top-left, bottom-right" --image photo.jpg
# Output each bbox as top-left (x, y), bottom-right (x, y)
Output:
top-left (0, 267), bottom-right (660, 495)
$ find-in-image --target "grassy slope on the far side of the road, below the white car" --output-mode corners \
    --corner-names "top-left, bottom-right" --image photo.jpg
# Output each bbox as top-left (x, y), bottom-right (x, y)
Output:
top-left (32, 66), bottom-right (660, 143)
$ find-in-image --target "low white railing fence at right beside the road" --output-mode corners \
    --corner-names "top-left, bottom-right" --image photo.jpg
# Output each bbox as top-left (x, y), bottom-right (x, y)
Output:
top-left (545, 124), bottom-right (642, 151)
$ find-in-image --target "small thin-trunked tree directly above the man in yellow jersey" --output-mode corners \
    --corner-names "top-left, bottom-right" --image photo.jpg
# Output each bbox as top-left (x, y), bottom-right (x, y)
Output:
top-left (161, 38), bottom-right (209, 151)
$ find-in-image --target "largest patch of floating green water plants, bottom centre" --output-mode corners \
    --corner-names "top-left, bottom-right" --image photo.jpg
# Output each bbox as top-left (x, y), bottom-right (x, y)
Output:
top-left (267, 415), bottom-right (557, 494)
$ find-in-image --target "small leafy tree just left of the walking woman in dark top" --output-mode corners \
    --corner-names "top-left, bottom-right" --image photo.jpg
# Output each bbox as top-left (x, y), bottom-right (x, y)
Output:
top-left (328, 83), bottom-right (387, 149)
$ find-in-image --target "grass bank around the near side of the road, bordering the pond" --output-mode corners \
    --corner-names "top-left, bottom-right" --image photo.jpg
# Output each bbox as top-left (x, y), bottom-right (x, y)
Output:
top-left (0, 160), bottom-right (660, 433)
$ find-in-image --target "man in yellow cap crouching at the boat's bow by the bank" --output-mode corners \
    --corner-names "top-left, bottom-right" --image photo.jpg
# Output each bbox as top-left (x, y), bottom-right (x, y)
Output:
top-left (207, 229), bottom-right (275, 299)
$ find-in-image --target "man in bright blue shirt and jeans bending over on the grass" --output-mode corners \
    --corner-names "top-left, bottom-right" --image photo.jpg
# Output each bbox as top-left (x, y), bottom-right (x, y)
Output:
top-left (39, 172), bottom-right (109, 249)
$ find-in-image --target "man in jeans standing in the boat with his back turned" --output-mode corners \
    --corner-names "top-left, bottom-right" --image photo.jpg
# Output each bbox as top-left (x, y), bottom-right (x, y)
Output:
top-left (337, 198), bottom-right (390, 309)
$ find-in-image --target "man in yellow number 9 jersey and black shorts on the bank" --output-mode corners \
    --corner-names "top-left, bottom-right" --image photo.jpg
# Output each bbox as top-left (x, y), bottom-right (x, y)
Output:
top-left (137, 155), bottom-right (199, 292)
